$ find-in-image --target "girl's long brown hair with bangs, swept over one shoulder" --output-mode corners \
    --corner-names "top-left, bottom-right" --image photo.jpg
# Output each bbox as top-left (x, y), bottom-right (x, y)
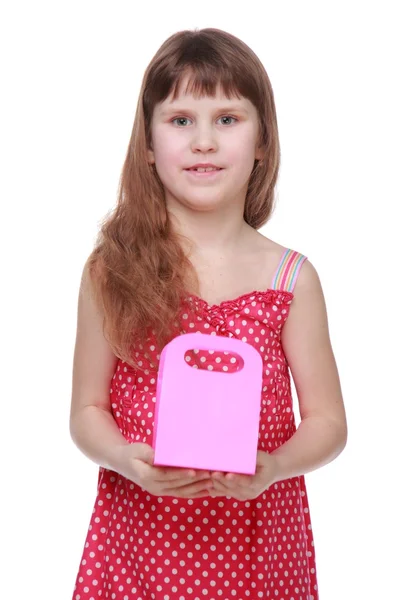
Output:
top-left (87, 28), bottom-right (280, 366)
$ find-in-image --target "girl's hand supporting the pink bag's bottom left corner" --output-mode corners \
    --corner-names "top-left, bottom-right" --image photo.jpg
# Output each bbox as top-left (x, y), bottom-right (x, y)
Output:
top-left (116, 442), bottom-right (213, 498)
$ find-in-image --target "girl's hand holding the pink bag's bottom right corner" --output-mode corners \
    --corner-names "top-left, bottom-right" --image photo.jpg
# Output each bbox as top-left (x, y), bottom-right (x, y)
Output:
top-left (209, 450), bottom-right (279, 501)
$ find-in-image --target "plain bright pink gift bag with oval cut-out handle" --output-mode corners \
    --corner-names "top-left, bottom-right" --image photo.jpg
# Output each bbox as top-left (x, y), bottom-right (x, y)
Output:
top-left (153, 333), bottom-right (263, 475)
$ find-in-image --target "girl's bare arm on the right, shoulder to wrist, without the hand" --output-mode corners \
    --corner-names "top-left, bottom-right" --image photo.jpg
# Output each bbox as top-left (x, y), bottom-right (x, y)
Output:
top-left (271, 261), bottom-right (347, 481)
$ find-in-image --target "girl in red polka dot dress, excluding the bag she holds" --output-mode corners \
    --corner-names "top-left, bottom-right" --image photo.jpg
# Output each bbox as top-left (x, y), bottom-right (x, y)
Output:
top-left (70, 29), bottom-right (347, 600)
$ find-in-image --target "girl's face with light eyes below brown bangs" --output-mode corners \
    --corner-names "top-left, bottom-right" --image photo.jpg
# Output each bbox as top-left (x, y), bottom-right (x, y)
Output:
top-left (148, 77), bottom-right (263, 211)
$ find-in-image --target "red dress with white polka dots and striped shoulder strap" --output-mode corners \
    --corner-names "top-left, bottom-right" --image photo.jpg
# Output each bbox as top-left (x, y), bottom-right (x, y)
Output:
top-left (73, 250), bottom-right (318, 600)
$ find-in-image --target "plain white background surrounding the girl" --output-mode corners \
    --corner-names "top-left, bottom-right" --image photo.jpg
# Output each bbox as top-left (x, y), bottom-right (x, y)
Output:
top-left (0, 0), bottom-right (400, 600)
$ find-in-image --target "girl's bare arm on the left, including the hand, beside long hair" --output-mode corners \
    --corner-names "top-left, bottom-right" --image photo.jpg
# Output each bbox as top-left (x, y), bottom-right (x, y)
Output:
top-left (70, 265), bottom-right (212, 498)
